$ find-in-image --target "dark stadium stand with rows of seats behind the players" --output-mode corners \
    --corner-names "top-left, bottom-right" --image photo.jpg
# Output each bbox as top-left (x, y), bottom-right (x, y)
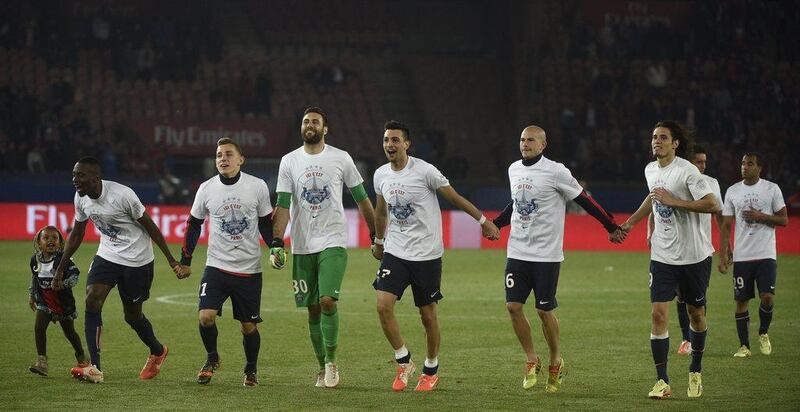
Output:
top-left (0, 0), bottom-right (800, 206)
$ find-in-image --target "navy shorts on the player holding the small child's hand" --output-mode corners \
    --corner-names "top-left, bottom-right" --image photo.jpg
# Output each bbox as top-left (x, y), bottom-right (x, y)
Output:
top-left (86, 255), bottom-right (153, 304)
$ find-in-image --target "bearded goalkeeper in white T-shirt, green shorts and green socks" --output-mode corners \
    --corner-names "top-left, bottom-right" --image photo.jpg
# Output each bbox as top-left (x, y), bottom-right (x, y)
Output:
top-left (270, 107), bottom-right (375, 388)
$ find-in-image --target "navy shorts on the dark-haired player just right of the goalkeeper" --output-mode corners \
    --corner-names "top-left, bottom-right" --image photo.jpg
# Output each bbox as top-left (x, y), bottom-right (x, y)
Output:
top-left (372, 253), bottom-right (444, 307)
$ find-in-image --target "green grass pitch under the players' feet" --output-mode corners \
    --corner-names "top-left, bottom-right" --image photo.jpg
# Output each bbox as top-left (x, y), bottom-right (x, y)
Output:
top-left (0, 242), bottom-right (800, 411)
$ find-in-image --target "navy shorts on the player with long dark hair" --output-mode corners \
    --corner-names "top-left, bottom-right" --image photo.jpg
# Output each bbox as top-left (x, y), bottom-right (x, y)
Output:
top-left (650, 256), bottom-right (711, 306)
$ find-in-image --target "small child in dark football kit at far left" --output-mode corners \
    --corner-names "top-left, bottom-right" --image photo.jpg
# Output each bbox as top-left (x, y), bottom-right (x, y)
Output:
top-left (28, 226), bottom-right (89, 376)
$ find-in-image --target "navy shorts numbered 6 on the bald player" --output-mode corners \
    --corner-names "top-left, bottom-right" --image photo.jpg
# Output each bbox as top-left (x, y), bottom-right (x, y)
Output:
top-left (505, 258), bottom-right (561, 311)
